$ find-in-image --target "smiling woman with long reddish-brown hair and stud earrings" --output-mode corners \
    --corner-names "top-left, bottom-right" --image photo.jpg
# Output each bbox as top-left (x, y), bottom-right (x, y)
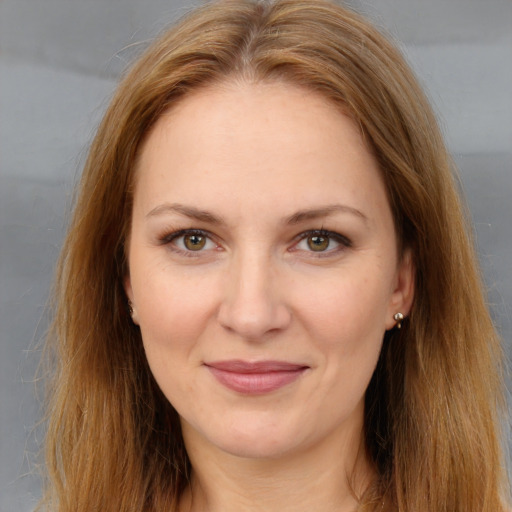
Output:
top-left (39, 0), bottom-right (507, 512)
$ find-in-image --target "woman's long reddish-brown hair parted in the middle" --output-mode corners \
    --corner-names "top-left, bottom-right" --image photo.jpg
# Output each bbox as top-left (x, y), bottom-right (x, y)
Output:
top-left (38, 0), bottom-right (506, 512)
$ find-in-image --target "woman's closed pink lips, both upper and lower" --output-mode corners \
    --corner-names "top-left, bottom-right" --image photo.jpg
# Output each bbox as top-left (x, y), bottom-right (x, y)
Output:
top-left (206, 360), bottom-right (308, 395)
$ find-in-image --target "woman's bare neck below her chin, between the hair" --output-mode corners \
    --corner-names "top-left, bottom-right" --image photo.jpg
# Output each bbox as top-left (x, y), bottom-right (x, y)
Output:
top-left (180, 418), bottom-right (373, 512)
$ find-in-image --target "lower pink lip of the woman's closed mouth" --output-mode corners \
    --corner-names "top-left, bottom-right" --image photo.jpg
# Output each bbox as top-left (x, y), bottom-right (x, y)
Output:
top-left (208, 366), bottom-right (306, 395)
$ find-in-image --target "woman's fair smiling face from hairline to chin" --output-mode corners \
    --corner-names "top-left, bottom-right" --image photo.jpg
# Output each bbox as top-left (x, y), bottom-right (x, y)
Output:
top-left (125, 83), bottom-right (412, 457)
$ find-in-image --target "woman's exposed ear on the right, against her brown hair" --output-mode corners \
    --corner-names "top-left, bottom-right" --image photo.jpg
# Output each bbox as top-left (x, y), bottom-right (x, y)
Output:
top-left (386, 249), bottom-right (416, 330)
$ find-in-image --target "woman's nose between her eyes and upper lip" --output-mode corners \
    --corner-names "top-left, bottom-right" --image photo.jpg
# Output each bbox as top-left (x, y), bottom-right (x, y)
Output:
top-left (218, 251), bottom-right (291, 341)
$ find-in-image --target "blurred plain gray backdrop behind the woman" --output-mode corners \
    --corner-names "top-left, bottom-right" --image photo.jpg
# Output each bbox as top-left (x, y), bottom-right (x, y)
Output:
top-left (0, 0), bottom-right (512, 512)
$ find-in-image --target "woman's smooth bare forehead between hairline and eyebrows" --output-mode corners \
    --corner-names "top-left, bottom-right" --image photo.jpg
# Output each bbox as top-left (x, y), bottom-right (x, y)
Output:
top-left (135, 83), bottom-right (387, 226)
